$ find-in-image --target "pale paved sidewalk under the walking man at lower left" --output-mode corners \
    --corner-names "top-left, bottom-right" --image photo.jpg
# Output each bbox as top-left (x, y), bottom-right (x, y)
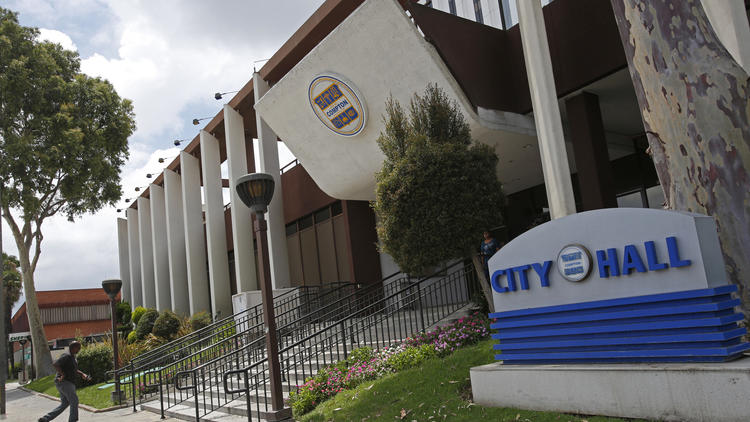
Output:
top-left (0, 383), bottom-right (176, 422)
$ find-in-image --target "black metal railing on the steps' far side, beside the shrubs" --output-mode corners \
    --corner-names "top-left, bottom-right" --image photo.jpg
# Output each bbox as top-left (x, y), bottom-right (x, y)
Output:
top-left (119, 283), bottom-right (354, 410)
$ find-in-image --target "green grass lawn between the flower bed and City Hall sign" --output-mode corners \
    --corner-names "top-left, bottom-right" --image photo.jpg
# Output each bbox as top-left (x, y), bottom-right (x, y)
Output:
top-left (298, 340), bottom-right (652, 422)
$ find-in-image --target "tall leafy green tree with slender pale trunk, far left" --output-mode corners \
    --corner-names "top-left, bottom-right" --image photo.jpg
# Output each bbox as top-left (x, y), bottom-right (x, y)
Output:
top-left (0, 8), bottom-right (135, 376)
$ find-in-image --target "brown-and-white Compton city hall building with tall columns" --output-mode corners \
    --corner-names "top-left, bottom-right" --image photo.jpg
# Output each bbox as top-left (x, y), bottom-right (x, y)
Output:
top-left (117, 0), bottom-right (750, 316)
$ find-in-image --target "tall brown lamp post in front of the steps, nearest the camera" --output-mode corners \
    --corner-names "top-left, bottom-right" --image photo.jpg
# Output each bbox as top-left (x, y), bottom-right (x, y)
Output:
top-left (235, 173), bottom-right (291, 420)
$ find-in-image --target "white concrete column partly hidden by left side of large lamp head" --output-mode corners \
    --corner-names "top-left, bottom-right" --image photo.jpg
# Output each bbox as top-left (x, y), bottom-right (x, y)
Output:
top-left (224, 104), bottom-right (259, 293)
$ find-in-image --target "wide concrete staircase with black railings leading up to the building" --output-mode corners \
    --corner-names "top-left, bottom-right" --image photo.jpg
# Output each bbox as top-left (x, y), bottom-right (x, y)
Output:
top-left (132, 263), bottom-right (476, 421)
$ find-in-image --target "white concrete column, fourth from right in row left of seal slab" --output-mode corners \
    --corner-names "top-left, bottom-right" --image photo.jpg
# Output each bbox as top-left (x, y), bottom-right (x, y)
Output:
top-left (180, 151), bottom-right (211, 314)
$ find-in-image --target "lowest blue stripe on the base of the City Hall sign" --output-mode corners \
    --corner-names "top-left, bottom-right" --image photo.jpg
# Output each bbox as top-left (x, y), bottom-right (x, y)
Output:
top-left (495, 343), bottom-right (750, 362)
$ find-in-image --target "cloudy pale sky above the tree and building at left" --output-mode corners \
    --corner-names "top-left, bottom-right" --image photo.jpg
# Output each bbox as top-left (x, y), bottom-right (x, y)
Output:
top-left (0, 0), bottom-right (323, 311)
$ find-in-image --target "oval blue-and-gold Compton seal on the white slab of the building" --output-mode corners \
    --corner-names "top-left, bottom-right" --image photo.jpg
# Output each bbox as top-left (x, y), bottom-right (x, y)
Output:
top-left (307, 73), bottom-right (366, 136)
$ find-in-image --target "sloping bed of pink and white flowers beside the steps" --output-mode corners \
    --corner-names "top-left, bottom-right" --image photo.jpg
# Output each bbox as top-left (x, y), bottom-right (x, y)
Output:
top-left (288, 312), bottom-right (490, 416)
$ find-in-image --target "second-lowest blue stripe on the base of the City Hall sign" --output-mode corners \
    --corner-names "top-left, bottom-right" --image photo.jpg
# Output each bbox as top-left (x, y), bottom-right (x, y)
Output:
top-left (493, 328), bottom-right (747, 350)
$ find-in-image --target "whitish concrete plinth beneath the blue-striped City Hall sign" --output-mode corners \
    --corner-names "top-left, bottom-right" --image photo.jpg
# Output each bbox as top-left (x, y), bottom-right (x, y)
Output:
top-left (471, 357), bottom-right (750, 422)
